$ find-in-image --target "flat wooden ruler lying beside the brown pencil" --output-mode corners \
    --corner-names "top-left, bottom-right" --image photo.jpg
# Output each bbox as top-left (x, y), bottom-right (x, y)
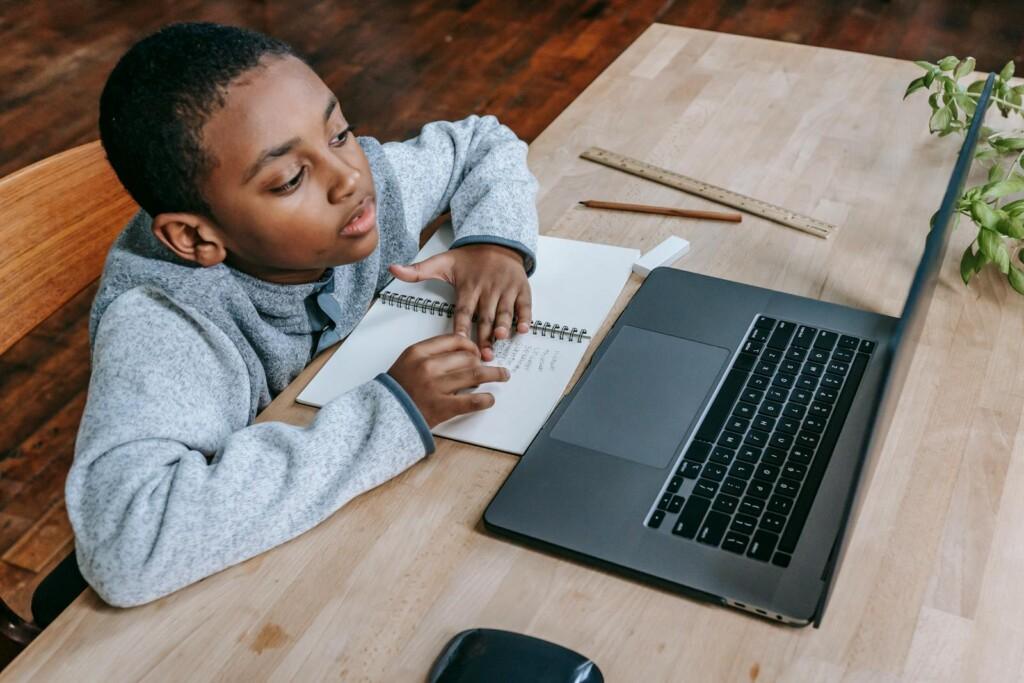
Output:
top-left (580, 147), bottom-right (836, 239)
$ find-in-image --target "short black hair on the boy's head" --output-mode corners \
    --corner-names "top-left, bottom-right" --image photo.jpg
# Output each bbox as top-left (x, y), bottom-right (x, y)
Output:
top-left (99, 23), bottom-right (298, 217)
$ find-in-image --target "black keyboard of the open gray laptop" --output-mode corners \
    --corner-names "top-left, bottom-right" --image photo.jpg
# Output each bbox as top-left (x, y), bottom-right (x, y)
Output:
top-left (647, 315), bottom-right (874, 567)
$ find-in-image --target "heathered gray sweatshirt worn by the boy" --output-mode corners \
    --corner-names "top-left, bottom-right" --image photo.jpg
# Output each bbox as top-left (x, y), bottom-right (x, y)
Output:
top-left (66, 116), bottom-right (538, 606)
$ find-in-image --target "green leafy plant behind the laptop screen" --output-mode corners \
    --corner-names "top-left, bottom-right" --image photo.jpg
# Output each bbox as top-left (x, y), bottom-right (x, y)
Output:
top-left (903, 56), bottom-right (1024, 294)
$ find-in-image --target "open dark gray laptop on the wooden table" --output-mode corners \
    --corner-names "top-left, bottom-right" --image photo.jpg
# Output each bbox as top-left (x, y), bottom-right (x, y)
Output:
top-left (483, 76), bottom-right (993, 626)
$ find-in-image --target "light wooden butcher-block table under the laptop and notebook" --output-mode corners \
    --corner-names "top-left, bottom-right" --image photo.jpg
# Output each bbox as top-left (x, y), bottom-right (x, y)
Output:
top-left (4, 25), bottom-right (1024, 681)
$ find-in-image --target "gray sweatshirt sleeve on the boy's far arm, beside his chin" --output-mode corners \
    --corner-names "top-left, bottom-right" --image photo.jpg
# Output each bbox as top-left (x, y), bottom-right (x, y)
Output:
top-left (383, 116), bottom-right (538, 273)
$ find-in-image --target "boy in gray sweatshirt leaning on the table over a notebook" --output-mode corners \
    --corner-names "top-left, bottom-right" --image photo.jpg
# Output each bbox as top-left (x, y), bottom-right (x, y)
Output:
top-left (67, 24), bottom-right (537, 606)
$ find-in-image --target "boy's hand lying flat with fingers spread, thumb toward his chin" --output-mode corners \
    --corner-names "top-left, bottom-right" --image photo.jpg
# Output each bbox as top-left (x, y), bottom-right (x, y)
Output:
top-left (389, 244), bottom-right (532, 360)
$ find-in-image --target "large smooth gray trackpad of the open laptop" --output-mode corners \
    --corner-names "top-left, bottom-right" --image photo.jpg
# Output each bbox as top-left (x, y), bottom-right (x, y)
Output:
top-left (551, 326), bottom-right (729, 468)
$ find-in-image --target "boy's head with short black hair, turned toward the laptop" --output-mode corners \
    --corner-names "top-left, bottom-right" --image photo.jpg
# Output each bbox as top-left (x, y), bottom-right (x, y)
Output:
top-left (99, 24), bottom-right (378, 283)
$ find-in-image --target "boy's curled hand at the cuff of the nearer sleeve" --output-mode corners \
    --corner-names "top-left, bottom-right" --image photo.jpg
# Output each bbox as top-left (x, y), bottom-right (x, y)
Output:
top-left (387, 334), bottom-right (509, 428)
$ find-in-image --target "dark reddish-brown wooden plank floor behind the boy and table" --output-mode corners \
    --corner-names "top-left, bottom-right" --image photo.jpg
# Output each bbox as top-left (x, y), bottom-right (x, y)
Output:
top-left (0, 0), bottom-right (1024, 660)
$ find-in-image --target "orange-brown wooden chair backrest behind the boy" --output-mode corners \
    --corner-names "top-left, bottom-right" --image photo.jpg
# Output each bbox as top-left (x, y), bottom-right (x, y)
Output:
top-left (0, 140), bottom-right (138, 353)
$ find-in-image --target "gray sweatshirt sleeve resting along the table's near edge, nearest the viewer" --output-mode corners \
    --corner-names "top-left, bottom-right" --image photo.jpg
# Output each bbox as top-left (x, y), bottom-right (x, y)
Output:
top-left (66, 289), bottom-right (433, 606)
